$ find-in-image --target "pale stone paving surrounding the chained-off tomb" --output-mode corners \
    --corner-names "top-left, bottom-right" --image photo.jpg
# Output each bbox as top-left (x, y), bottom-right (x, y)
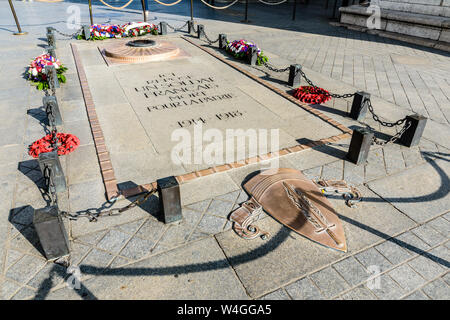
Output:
top-left (0, 1), bottom-right (450, 299)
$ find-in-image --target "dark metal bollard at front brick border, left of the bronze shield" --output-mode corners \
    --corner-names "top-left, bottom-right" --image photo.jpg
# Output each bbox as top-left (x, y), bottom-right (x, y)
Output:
top-left (156, 176), bottom-right (183, 223)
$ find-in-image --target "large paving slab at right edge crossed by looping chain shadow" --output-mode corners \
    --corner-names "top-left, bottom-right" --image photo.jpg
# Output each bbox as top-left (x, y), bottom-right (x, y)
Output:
top-left (369, 160), bottom-right (450, 222)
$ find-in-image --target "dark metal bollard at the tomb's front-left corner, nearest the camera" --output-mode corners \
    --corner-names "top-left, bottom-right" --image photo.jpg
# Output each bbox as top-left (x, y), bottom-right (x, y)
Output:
top-left (33, 206), bottom-right (70, 260)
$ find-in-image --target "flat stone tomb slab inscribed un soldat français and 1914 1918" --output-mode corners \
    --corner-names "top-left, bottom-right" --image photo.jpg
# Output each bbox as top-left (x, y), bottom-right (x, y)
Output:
top-left (79, 37), bottom-right (342, 185)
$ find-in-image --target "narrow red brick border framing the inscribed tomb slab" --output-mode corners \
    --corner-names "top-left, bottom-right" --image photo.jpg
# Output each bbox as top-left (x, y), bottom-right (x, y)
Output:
top-left (71, 37), bottom-right (352, 200)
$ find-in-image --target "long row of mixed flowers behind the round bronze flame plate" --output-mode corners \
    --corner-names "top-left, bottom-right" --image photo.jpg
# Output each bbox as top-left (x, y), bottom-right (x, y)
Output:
top-left (77, 22), bottom-right (158, 40)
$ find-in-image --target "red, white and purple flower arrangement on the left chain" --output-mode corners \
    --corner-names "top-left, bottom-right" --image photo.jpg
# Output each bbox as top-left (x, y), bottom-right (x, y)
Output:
top-left (27, 53), bottom-right (67, 90)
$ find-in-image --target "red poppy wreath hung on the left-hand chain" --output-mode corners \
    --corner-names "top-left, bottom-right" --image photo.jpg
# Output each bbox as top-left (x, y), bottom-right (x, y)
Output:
top-left (28, 133), bottom-right (80, 158)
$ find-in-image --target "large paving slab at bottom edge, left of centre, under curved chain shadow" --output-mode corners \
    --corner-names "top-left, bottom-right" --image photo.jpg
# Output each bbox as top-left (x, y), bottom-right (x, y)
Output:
top-left (70, 238), bottom-right (248, 300)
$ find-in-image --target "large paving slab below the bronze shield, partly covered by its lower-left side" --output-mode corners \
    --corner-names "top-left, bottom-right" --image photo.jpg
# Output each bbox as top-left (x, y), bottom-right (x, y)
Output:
top-left (215, 219), bottom-right (342, 299)
